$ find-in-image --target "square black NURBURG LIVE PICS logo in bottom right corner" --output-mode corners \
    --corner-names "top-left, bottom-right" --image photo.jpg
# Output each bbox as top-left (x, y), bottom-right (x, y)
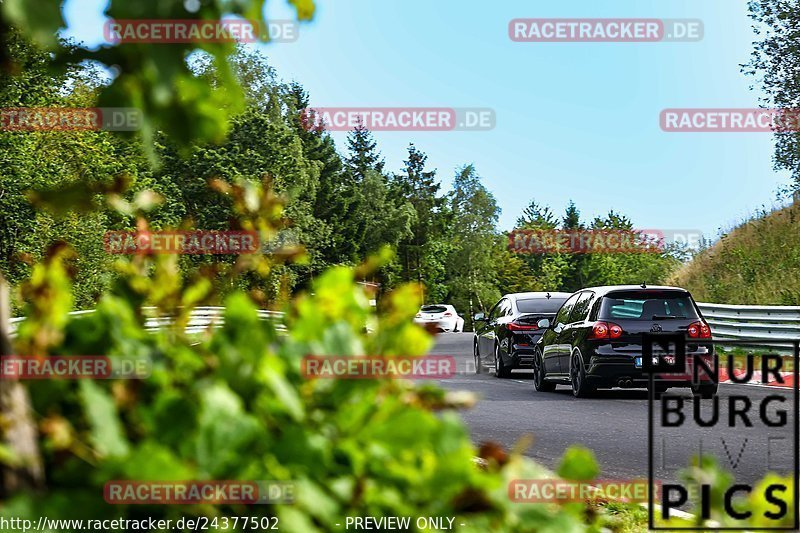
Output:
top-left (642, 332), bottom-right (800, 531)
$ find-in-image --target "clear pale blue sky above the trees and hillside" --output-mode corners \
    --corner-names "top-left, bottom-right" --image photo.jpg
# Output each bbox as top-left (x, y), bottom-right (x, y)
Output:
top-left (64, 0), bottom-right (789, 238)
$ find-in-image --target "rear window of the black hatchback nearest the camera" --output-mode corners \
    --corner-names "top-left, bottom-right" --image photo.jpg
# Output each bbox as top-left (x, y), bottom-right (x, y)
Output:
top-left (598, 290), bottom-right (699, 320)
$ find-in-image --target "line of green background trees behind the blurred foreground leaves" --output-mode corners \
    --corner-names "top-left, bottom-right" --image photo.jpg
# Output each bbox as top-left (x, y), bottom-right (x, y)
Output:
top-left (0, 30), bottom-right (680, 328)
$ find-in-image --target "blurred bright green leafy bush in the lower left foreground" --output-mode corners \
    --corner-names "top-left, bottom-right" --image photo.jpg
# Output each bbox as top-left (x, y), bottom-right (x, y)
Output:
top-left (2, 219), bottom-right (632, 531)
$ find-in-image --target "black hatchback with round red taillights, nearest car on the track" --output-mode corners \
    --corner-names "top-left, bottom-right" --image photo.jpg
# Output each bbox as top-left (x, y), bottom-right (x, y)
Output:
top-left (533, 285), bottom-right (717, 397)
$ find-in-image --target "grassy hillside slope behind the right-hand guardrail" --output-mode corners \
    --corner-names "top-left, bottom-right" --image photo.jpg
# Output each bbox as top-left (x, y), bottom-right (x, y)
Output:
top-left (670, 204), bottom-right (800, 305)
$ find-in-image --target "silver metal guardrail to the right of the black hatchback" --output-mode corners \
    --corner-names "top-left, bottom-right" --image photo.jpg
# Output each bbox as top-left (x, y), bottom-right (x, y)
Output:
top-left (697, 302), bottom-right (800, 348)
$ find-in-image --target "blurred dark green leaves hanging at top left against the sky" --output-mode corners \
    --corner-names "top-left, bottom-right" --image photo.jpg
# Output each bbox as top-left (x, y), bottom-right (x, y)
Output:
top-left (0, 0), bottom-right (314, 151)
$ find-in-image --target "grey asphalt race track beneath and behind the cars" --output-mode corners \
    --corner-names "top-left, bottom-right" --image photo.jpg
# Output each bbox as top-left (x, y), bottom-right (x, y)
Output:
top-left (424, 333), bottom-right (796, 490)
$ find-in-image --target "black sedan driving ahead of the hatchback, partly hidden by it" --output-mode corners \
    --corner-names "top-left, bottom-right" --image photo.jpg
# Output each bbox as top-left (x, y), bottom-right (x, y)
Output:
top-left (473, 292), bottom-right (572, 378)
